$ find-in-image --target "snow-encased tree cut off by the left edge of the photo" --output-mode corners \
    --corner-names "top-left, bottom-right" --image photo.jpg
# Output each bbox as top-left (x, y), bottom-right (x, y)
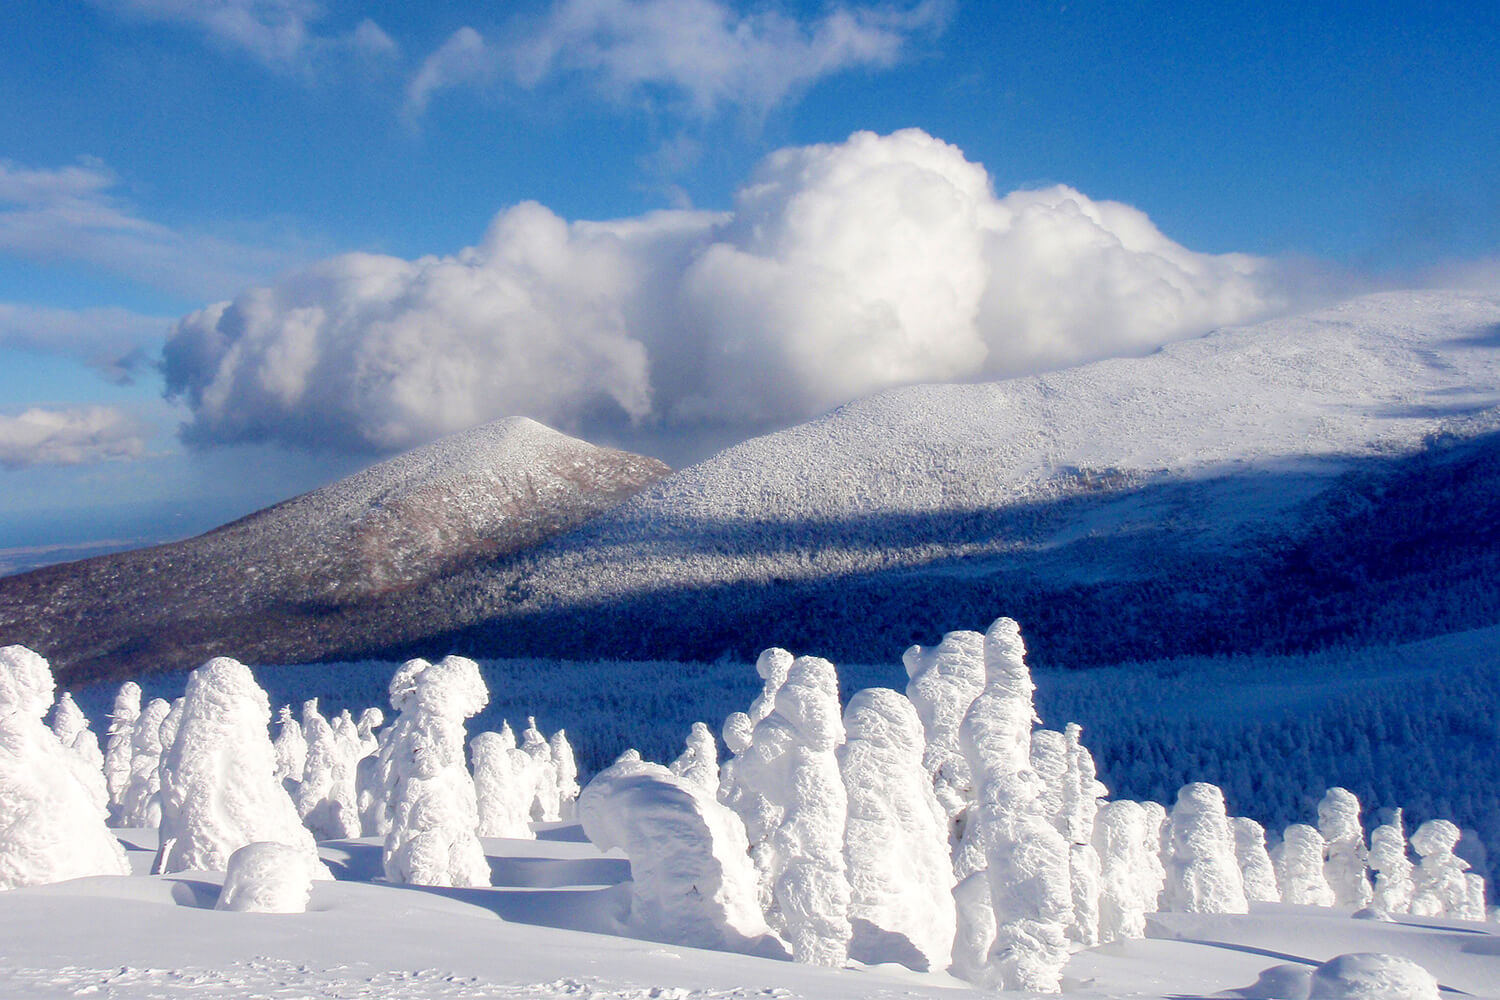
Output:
top-left (0, 646), bottom-right (131, 889)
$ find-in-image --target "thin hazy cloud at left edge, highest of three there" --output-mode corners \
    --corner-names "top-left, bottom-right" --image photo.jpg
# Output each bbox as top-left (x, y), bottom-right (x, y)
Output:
top-left (0, 159), bottom-right (300, 298)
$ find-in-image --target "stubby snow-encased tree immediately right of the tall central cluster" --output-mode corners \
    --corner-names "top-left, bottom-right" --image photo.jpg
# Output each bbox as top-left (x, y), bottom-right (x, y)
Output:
top-left (1094, 801), bottom-right (1161, 943)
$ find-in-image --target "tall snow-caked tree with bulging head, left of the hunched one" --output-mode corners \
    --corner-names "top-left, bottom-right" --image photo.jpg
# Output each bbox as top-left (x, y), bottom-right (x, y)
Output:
top-left (383, 657), bottom-right (489, 886)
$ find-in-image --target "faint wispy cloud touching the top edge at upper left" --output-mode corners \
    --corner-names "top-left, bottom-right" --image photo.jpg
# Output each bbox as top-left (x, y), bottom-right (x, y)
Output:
top-left (93, 0), bottom-right (398, 72)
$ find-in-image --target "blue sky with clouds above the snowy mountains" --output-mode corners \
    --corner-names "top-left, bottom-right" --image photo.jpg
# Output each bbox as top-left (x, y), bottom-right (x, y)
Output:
top-left (0, 0), bottom-right (1500, 563)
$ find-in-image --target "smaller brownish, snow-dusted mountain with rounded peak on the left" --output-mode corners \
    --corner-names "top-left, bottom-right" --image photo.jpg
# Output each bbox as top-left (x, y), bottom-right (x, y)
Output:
top-left (0, 418), bottom-right (668, 676)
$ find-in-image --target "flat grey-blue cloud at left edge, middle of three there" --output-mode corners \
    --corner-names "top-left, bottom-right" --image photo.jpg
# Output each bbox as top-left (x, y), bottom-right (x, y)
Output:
top-left (0, 303), bottom-right (173, 385)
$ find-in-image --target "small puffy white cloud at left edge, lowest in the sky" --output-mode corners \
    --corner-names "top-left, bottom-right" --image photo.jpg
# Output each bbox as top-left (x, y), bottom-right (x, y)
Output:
top-left (0, 406), bottom-right (150, 469)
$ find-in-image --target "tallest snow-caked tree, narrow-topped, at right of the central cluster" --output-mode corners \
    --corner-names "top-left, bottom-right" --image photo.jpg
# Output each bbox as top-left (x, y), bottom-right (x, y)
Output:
top-left (954, 618), bottom-right (1073, 993)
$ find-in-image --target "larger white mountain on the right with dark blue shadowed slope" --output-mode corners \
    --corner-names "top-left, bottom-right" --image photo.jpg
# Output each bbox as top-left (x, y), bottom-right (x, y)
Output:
top-left (413, 292), bottom-right (1500, 664)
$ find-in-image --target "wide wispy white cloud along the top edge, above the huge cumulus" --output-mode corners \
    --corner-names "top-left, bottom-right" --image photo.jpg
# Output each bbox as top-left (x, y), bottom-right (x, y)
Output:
top-left (407, 0), bottom-right (951, 115)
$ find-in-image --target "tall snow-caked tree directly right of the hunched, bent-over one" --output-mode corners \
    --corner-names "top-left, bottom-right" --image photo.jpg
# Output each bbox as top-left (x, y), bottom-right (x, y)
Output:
top-left (744, 654), bottom-right (851, 967)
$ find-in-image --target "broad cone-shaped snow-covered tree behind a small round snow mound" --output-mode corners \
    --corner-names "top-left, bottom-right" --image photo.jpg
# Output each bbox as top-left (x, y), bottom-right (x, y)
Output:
top-left (155, 657), bottom-right (327, 874)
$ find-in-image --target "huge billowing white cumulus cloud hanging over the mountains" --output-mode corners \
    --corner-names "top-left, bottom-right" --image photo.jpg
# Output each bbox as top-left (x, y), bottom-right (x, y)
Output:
top-left (165, 129), bottom-right (1284, 451)
